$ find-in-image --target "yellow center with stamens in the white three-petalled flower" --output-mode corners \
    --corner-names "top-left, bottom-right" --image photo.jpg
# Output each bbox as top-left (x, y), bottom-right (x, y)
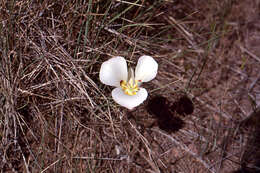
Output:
top-left (120, 78), bottom-right (139, 96)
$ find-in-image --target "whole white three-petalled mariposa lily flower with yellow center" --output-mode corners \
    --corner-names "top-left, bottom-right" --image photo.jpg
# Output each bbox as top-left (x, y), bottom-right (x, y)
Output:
top-left (99, 55), bottom-right (158, 109)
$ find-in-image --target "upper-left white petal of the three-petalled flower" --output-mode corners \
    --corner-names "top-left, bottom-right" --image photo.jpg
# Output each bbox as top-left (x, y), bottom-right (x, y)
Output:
top-left (99, 56), bottom-right (127, 87)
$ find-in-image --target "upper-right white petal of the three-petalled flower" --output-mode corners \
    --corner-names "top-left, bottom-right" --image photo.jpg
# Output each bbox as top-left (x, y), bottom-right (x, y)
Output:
top-left (135, 55), bottom-right (158, 82)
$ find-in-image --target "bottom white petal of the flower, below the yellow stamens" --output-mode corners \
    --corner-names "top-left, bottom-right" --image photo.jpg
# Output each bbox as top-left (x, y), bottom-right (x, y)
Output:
top-left (112, 88), bottom-right (148, 109)
